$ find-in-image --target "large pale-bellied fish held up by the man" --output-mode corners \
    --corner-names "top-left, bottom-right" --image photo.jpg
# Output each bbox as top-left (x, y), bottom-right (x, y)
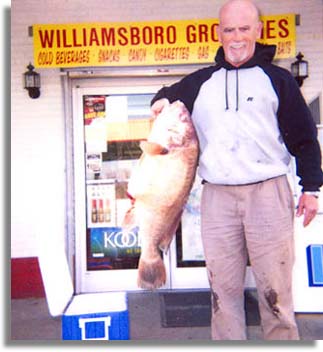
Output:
top-left (124, 101), bottom-right (198, 289)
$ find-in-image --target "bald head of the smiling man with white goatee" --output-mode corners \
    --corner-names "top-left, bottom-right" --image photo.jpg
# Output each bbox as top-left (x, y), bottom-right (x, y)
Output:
top-left (218, 0), bottom-right (262, 67)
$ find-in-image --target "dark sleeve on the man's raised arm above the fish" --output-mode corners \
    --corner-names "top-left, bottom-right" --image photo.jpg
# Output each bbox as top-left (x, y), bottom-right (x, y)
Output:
top-left (151, 66), bottom-right (217, 113)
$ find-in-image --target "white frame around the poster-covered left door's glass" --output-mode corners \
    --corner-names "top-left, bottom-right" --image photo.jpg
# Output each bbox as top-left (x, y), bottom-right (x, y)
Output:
top-left (72, 82), bottom-right (170, 294)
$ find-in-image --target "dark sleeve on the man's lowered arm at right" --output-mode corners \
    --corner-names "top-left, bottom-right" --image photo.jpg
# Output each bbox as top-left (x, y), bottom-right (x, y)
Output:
top-left (272, 69), bottom-right (323, 191)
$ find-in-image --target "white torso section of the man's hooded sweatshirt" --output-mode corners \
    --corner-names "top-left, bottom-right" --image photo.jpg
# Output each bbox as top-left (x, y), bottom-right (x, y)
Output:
top-left (192, 67), bottom-right (290, 185)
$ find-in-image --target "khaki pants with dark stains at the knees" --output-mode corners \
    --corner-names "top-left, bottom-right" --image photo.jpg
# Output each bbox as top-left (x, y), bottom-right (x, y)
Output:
top-left (201, 176), bottom-right (299, 340)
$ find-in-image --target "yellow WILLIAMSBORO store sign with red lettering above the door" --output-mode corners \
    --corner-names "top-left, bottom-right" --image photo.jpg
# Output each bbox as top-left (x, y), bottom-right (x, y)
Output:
top-left (33, 14), bottom-right (296, 68)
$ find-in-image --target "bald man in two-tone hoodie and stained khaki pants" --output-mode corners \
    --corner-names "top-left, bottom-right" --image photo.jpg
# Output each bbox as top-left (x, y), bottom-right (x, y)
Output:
top-left (152, 0), bottom-right (323, 340)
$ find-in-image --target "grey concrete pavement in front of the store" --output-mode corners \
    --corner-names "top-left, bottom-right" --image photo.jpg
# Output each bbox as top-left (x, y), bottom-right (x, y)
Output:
top-left (8, 292), bottom-right (323, 341)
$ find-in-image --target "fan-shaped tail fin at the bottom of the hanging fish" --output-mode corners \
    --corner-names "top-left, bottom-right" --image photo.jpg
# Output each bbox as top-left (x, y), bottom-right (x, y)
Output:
top-left (137, 256), bottom-right (166, 290)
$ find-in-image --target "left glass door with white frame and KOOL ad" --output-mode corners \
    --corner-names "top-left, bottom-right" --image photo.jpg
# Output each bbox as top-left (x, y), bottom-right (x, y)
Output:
top-left (73, 86), bottom-right (169, 293)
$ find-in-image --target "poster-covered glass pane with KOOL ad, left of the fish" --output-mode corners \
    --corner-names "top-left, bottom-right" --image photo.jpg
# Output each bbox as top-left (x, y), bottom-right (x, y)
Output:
top-left (83, 94), bottom-right (153, 270)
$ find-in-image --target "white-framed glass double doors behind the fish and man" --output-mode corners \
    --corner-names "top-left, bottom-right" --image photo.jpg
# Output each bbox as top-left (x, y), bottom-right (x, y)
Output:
top-left (72, 77), bottom-right (235, 293)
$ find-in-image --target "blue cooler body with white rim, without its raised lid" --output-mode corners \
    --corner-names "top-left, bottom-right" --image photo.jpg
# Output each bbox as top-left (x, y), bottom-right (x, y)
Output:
top-left (62, 292), bottom-right (129, 340)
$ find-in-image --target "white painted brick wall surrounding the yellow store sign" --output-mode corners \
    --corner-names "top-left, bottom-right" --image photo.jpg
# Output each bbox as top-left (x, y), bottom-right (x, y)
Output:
top-left (11, 0), bottom-right (323, 257)
